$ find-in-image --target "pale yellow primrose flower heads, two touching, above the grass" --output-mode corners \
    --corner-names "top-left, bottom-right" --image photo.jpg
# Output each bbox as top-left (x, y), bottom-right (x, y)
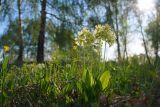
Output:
top-left (75, 24), bottom-right (116, 46)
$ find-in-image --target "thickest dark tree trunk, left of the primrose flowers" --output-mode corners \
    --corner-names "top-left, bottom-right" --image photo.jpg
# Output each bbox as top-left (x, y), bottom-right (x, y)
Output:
top-left (37, 0), bottom-right (47, 63)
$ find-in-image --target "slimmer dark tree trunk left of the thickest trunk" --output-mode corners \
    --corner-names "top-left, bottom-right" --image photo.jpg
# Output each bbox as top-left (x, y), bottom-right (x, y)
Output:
top-left (17, 0), bottom-right (23, 65)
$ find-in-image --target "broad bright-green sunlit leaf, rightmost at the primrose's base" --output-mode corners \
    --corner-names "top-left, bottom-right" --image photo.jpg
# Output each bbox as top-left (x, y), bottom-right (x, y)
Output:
top-left (100, 71), bottom-right (111, 90)
